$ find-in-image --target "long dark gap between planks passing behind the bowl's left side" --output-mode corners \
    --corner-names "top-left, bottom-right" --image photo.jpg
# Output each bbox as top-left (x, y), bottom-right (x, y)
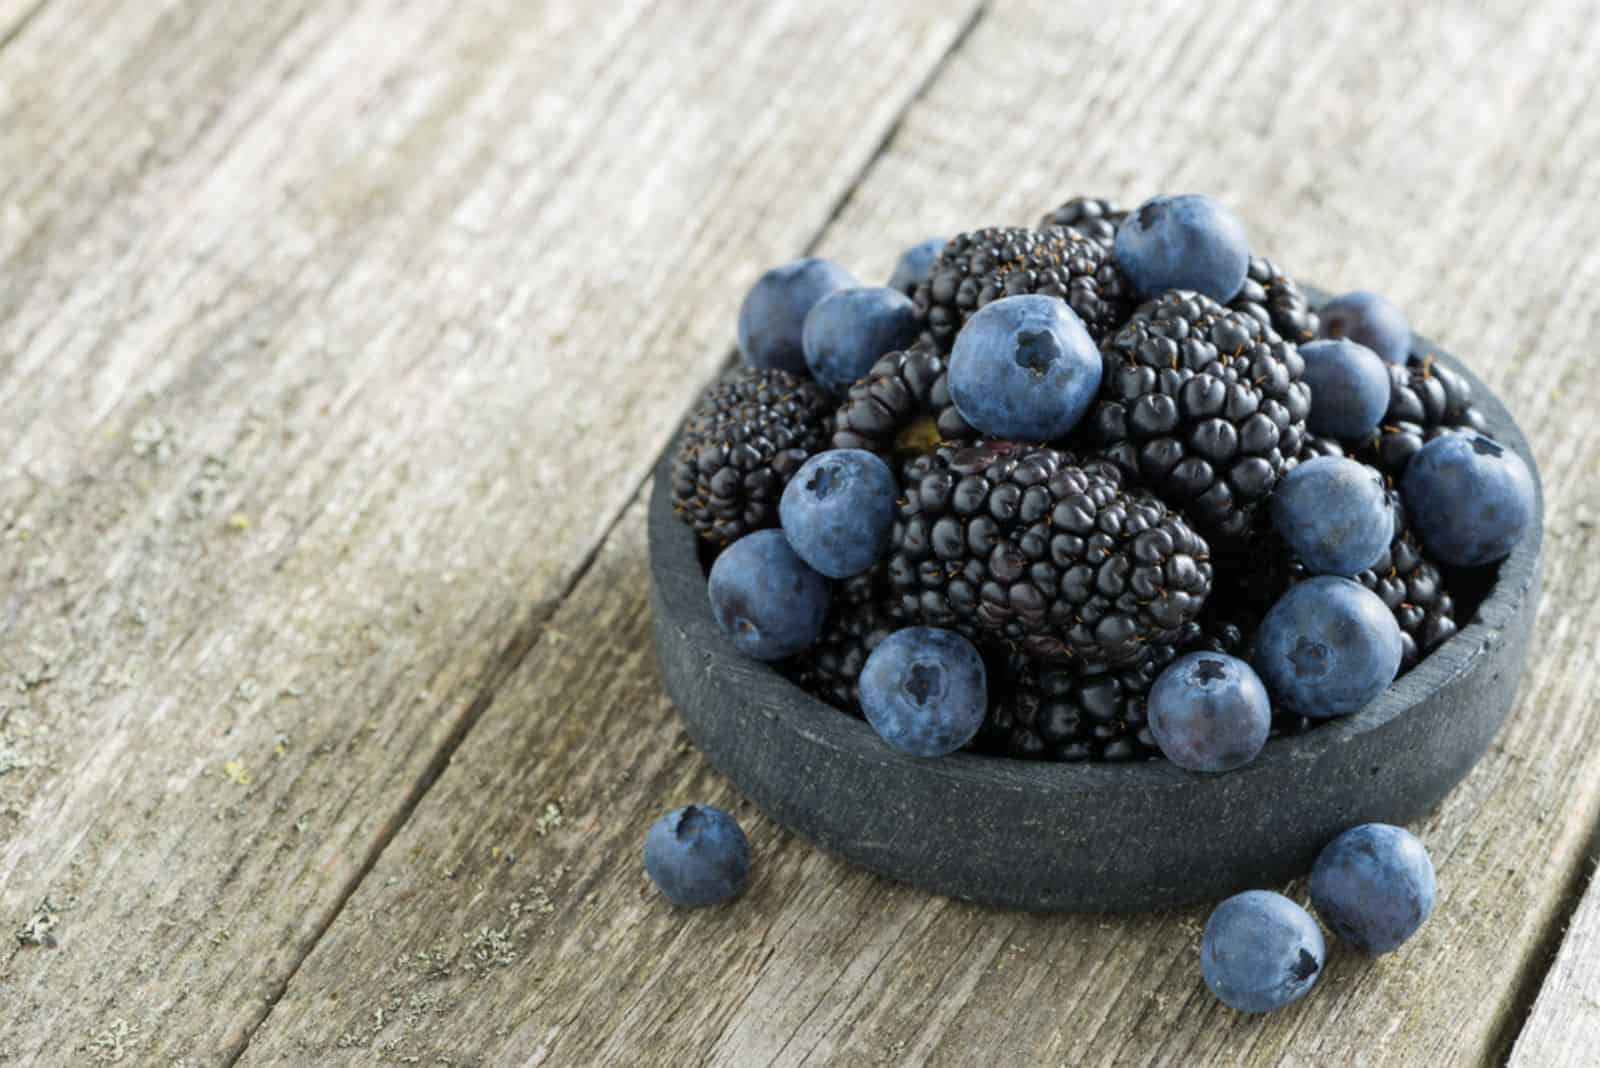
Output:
top-left (219, 0), bottom-right (989, 1065)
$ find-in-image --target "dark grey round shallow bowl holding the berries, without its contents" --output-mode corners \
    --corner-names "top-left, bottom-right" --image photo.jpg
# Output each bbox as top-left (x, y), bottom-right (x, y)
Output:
top-left (650, 339), bottom-right (1544, 911)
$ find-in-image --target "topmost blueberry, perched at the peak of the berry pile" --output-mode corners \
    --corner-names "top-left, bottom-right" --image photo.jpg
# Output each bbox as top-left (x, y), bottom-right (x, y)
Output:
top-left (1112, 193), bottom-right (1250, 304)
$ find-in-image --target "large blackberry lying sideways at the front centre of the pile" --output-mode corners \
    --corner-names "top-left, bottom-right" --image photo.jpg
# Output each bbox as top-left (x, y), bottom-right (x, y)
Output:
top-left (888, 441), bottom-right (1211, 664)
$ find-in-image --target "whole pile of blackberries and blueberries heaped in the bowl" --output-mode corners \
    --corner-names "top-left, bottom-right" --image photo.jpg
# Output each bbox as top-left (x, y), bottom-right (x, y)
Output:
top-left (672, 195), bottom-right (1534, 772)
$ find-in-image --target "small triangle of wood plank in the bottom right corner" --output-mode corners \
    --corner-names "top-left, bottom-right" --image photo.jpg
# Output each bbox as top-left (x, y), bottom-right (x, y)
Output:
top-left (1510, 859), bottom-right (1600, 1068)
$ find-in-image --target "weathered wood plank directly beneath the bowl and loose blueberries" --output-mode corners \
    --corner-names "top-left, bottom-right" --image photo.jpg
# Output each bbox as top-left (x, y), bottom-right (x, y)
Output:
top-left (233, 3), bottom-right (1600, 1066)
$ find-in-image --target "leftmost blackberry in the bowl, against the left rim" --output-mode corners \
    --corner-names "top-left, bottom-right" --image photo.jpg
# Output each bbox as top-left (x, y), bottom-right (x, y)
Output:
top-left (672, 368), bottom-right (834, 544)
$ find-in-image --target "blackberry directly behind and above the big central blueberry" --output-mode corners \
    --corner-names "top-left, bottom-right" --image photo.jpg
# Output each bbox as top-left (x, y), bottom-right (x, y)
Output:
top-left (915, 227), bottom-right (1133, 352)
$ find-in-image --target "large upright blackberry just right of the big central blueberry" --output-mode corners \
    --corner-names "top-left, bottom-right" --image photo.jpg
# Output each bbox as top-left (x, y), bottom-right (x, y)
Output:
top-left (1083, 289), bottom-right (1310, 544)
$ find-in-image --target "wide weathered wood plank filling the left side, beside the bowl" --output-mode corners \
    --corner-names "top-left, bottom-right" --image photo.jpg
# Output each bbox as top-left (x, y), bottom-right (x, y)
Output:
top-left (0, 0), bottom-right (963, 1063)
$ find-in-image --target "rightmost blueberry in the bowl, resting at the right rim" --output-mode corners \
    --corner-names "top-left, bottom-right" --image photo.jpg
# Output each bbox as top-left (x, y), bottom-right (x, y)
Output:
top-left (1400, 433), bottom-right (1534, 568)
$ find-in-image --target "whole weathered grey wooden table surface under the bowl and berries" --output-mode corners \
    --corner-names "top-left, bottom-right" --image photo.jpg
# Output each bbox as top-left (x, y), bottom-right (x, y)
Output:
top-left (0, 0), bottom-right (1600, 1068)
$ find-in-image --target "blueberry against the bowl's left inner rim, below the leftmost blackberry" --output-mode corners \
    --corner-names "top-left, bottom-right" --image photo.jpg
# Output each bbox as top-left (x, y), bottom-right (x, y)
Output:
top-left (706, 531), bottom-right (829, 660)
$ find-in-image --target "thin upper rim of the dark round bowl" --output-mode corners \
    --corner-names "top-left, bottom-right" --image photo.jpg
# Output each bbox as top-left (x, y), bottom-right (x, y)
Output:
top-left (648, 329), bottom-right (1544, 793)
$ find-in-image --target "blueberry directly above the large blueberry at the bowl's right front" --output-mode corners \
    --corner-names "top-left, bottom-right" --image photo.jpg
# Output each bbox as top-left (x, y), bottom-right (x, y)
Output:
top-left (1272, 456), bottom-right (1395, 577)
